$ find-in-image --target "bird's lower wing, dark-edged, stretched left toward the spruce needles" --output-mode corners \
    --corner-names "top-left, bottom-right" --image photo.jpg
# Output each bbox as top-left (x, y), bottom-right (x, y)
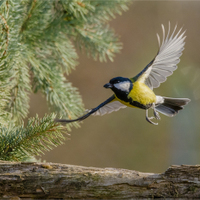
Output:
top-left (55, 95), bottom-right (127, 123)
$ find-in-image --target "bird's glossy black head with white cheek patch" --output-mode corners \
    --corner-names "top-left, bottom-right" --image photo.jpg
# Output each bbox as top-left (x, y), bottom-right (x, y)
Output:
top-left (104, 77), bottom-right (133, 94)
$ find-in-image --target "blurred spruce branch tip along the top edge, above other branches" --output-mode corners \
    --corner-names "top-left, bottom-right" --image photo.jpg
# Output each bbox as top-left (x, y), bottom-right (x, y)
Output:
top-left (61, 0), bottom-right (132, 24)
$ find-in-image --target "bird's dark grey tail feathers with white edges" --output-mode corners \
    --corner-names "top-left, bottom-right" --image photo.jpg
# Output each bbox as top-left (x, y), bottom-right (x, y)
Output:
top-left (155, 96), bottom-right (190, 117)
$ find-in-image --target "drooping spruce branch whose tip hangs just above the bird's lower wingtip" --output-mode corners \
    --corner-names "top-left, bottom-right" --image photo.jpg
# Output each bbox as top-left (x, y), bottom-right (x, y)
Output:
top-left (29, 45), bottom-right (83, 127)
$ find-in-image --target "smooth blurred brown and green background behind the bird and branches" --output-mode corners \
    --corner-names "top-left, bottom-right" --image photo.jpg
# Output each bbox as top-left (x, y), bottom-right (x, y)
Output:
top-left (29, 1), bottom-right (200, 172)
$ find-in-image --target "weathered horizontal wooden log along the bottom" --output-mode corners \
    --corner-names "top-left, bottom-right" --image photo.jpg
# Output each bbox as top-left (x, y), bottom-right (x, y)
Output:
top-left (0, 161), bottom-right (200, 199)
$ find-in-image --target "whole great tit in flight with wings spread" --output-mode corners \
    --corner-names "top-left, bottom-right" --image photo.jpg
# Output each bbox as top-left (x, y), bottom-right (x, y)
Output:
top-left (56, 23), bottom-right (190, 125)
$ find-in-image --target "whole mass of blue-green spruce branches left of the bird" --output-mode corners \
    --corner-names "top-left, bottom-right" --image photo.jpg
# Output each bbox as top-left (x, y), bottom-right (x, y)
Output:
top-left (0, 0), bottom-right (130, 160)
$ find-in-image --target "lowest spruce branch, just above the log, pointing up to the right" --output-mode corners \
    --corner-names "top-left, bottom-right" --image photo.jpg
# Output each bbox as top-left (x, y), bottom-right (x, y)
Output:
top-left (0, 114), bottom-right (66, 161)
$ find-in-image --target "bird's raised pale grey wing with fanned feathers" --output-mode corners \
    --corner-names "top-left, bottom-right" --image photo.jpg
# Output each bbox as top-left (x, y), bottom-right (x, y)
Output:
top-left (131, 23), bottom-right (186, 89)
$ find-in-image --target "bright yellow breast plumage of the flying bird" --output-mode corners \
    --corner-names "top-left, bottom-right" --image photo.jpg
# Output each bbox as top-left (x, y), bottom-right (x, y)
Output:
top-left (117, 81), bottom-right (156, 107)
